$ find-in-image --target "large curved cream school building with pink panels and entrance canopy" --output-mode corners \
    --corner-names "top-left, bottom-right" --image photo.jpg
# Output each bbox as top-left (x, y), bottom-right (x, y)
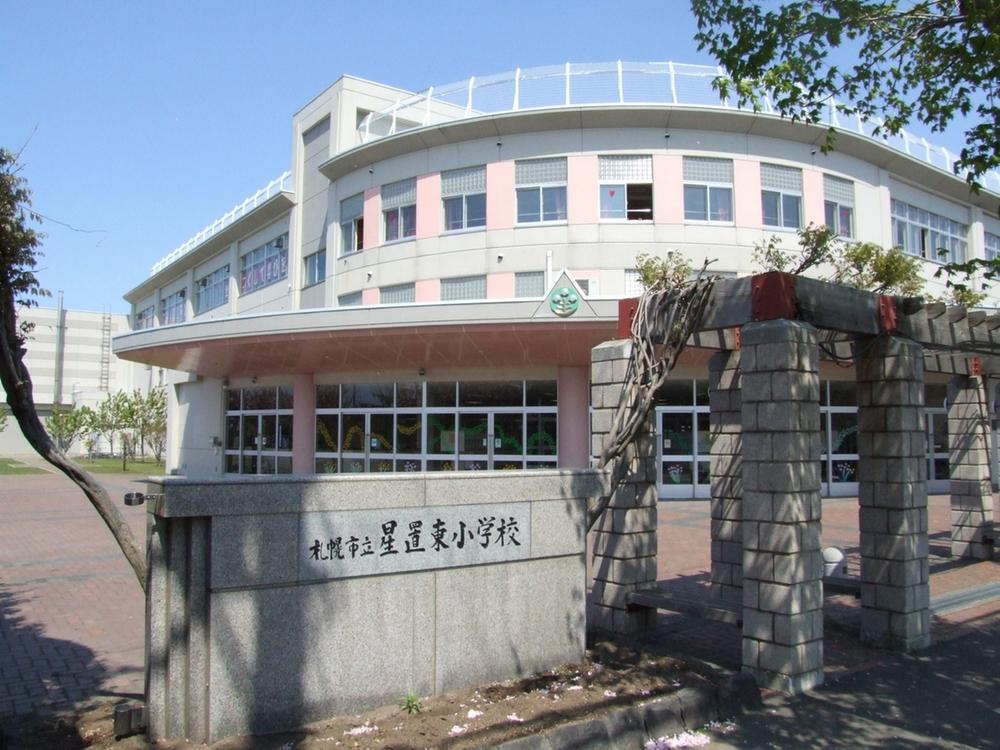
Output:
top-left (115, 62), bottom-right (1000, 497)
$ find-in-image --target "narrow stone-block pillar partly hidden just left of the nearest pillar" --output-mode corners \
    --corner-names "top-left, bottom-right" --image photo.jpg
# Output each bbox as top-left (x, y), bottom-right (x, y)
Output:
top-left (708, 351), bottom-right (743, 602)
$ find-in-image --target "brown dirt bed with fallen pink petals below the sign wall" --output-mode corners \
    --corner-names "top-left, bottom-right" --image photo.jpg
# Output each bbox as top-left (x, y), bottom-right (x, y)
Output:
top-left (1, 643), bottom-right (720, 750)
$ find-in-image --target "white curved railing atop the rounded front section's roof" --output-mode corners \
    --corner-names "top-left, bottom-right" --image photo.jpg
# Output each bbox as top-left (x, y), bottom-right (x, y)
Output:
top-left (358, 60), bottom-right (1000, 193)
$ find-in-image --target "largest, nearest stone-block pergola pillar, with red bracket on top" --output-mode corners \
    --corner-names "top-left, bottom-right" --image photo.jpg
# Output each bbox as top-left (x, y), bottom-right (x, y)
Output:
top-left (740, 320), bottom-right (823, 693)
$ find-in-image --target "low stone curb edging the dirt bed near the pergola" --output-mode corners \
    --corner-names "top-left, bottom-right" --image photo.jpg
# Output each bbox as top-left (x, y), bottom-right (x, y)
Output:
top-left (484, 674), bottom-right (761, 750)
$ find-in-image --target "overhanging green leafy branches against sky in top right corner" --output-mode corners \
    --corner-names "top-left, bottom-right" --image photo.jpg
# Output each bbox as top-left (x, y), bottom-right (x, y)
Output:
top-left (691, 0), bottom-right (1000, 187)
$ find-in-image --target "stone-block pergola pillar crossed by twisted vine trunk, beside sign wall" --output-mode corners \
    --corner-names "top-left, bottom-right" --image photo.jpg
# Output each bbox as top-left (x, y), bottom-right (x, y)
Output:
top-left (588, 341), bottom-right (657, 633)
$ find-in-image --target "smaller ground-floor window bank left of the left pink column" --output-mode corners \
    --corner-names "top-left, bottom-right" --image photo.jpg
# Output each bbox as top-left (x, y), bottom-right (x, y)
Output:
top-left (225, 385), bottom-right (294, 474)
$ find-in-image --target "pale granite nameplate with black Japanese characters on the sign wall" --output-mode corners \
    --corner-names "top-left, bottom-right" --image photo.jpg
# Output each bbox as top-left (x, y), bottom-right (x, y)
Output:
top-left (299, 503), bottom-right (531, 580)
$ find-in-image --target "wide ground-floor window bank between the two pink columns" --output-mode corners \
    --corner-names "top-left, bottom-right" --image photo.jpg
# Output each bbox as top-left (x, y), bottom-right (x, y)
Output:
top-left (316, 380), bottom-right (558, 474)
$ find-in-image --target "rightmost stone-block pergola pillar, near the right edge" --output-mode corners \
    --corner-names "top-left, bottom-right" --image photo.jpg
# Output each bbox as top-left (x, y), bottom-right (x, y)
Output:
top-left (948, 375), bottom-right (993, 560)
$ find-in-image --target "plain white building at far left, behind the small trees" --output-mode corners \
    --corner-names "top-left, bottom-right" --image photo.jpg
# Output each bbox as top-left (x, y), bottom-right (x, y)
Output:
top-left (0, 306), bottom-right (155, 456)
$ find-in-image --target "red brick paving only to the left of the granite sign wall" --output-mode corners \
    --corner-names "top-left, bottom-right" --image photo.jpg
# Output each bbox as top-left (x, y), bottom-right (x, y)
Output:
top-left (0, 474), bottom-right (145, 719)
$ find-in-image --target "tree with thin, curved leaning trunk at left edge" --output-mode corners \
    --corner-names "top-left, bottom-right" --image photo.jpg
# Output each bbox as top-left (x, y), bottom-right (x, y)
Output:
top-left (0, 149), bottom-right (146, 591)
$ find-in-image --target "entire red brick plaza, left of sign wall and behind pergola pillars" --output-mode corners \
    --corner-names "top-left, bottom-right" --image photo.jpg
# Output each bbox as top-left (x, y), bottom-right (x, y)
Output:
top-left (0, 474), bottom-right (1000, 720)
